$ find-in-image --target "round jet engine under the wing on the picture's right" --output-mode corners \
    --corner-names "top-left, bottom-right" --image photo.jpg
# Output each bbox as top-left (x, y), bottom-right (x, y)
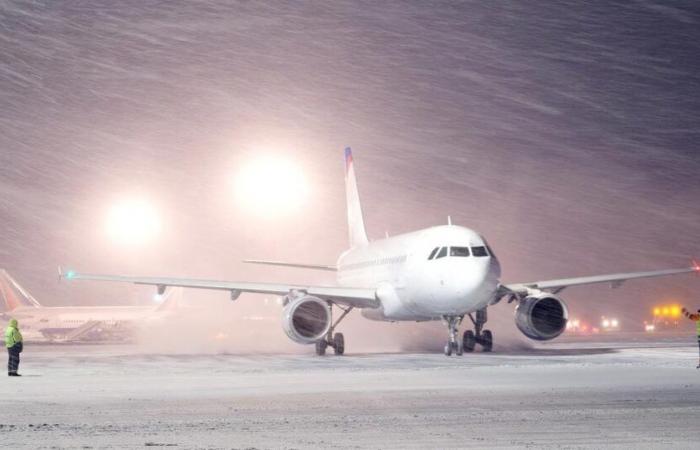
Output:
top-left (515, 292), bottom-right (569, 341)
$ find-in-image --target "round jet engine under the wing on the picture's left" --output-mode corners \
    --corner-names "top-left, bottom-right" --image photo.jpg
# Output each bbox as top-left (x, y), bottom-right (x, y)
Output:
top-left (282, 295), bottom-right (331, 344)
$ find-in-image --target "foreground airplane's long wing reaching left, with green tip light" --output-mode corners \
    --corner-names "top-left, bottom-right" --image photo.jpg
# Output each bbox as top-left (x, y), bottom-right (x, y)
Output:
top-left (59, 268), bottom-right (380, 308)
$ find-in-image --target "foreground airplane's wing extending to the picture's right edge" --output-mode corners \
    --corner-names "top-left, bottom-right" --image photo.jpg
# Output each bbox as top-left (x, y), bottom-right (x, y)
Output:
top-left (503, 261), bottom-right (700, 294)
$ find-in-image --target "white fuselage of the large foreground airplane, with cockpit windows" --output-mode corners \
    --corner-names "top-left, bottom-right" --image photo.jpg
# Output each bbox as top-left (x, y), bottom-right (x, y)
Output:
top-left (337, 225), bottom-right (501, 321)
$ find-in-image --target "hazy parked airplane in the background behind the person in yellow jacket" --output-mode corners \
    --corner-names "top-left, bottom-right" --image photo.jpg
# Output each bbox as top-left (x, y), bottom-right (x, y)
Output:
top-left (0, 269), bottom-right (179, 342)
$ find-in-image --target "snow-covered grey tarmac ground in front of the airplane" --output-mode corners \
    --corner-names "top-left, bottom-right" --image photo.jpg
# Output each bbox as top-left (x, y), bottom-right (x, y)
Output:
top-left (0, 340), bottom-right (700, 449)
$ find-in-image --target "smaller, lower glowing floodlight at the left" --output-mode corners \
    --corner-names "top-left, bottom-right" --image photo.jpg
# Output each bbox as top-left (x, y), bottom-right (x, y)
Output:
top-left (106, 200), bottom-right (161, 245)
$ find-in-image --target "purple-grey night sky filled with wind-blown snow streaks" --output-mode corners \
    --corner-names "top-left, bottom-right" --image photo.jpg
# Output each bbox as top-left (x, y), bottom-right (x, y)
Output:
top-left (0, 1), bottom-right (700, 333)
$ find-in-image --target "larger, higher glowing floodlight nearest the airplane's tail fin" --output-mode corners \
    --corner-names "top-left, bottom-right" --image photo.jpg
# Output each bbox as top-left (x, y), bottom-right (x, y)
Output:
top-left (234, 157), bottom-right (309, 217)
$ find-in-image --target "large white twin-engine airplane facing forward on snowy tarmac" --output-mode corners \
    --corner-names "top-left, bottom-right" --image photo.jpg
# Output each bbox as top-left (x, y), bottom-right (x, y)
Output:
top-left (59, 148), bottom-right (700, 356)
